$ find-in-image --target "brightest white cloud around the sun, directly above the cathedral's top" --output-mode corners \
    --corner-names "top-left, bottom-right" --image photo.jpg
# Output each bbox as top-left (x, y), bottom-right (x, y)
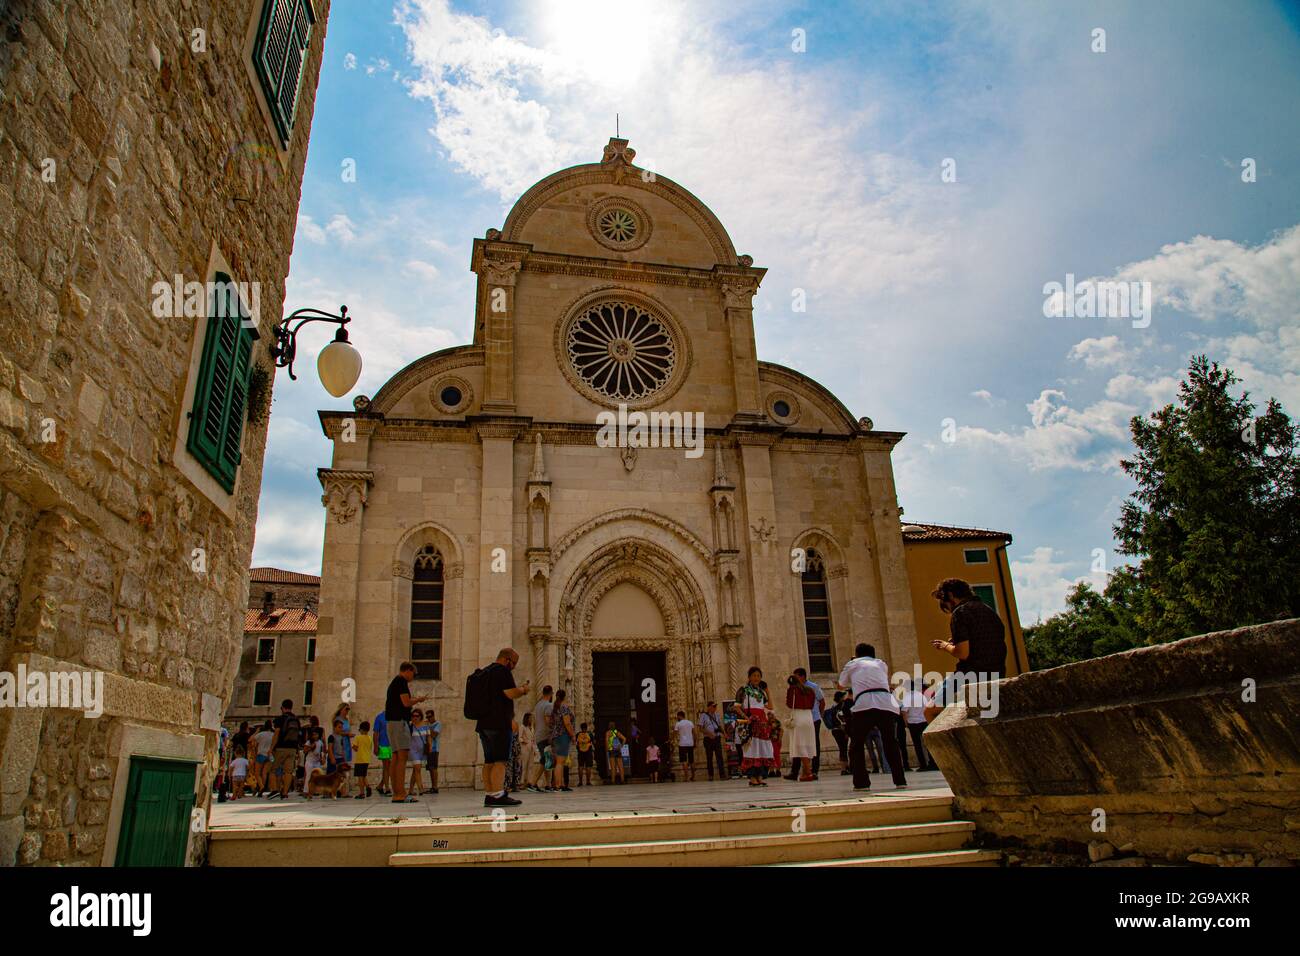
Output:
top-left (398, 0), bottom-right (962, 297)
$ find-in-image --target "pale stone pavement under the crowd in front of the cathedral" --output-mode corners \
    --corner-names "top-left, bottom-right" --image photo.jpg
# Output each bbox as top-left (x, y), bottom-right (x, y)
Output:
top-left (209, 770), bottom-right (952, 830)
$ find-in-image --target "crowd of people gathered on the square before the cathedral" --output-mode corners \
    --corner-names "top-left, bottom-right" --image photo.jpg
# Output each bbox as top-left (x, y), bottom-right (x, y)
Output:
top-left (221, 579), bottom-right (1006, 806)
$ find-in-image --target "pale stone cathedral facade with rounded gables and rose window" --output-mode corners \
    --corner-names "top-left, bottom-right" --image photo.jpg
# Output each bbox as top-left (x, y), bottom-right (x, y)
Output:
top-left (313, 139), bottom-right (917, 784)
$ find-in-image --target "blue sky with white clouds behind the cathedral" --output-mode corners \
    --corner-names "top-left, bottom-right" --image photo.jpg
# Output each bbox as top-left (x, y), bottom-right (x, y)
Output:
top-left (254, 0), bottom-right (1300, 622)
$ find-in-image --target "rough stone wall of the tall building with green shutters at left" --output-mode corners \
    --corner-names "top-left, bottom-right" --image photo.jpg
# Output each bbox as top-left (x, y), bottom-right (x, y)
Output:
top-left (0, 0), bottom-right (329, 865)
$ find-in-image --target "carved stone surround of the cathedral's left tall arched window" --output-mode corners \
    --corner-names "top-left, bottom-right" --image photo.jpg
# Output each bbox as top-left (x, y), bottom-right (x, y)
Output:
top-left (389, 522), bottom-right (464, 689)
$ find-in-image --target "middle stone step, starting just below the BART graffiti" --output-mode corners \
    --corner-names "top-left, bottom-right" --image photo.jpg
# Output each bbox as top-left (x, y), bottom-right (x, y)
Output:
top-left (389, 821), bottom-right (975, 866)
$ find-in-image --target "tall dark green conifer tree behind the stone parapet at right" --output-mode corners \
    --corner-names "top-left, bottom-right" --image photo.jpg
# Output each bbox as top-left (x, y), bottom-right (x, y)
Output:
top-left (1108, 355), bottom-right (1300, 643)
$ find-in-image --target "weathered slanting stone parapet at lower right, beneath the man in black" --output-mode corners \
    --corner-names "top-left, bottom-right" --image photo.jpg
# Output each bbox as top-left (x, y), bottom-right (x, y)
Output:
top-left (926, 619), bottom-right (1300, 864)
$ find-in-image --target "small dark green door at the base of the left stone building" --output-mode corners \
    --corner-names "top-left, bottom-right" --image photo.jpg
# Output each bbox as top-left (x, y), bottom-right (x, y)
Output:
top-left (117, 757), bottom-right (198, 866)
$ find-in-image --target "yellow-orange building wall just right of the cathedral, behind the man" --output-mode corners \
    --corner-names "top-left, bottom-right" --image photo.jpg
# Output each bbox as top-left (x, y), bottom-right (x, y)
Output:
top-left (904, 538), bottom-right (1028, 676)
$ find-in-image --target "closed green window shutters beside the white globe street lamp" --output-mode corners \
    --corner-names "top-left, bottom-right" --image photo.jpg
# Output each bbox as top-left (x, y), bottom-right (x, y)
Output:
top-left (186, 272), bottom-right (254, 493)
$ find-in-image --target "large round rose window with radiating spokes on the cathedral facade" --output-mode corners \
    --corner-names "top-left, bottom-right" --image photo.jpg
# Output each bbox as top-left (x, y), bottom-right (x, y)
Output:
top-left (566, 300), bottom-right (677, 402)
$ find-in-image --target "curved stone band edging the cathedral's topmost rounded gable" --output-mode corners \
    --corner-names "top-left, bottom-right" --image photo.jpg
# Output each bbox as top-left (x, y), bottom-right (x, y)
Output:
top-left (501, 137), bottom-right (753, 265)
